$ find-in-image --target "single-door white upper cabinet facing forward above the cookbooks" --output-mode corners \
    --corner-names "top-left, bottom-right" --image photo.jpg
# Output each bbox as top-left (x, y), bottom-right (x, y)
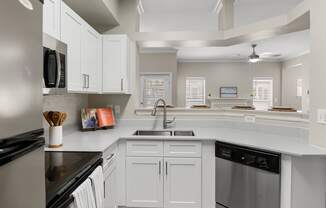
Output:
top-left (102, 35), bottom-right (134, 94)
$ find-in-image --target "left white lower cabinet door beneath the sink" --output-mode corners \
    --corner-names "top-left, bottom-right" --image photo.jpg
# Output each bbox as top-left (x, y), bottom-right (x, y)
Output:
top-left (126, 157), bottom-right (163, 207)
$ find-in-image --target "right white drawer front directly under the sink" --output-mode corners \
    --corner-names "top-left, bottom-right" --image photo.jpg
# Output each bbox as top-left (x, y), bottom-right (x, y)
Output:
top-left (164, 141), bottom-right (201, 157)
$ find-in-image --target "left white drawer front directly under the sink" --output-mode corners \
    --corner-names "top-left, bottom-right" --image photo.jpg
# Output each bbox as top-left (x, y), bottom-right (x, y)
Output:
top-left (127, 141), bottom-right (163, 156)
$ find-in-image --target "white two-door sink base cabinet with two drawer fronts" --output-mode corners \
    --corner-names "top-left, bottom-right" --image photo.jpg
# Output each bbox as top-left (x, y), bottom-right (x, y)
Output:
top-left (126, 140), bottom-right (202, 208)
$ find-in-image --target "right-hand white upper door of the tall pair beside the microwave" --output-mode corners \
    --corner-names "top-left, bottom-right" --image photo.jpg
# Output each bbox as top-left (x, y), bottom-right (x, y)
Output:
top-left (81, 25), bottom-right (102, 93)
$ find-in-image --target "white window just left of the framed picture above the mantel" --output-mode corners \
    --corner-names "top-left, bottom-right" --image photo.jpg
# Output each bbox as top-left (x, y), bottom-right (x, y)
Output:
top-left (186, 77), bottom-right (206, 108)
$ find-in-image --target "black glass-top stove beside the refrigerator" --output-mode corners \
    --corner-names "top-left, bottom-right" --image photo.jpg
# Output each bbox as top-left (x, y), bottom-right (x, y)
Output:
top-left (45, 152), bottom-right (102, 207)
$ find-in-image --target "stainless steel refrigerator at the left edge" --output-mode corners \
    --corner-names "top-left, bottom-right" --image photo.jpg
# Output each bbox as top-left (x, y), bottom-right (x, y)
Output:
top-left (0, 0), bottom-right (45, 208)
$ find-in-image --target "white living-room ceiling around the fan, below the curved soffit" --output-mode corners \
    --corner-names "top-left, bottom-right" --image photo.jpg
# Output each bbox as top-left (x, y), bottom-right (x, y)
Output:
top-left (177, 31), bottom-right (310, 61)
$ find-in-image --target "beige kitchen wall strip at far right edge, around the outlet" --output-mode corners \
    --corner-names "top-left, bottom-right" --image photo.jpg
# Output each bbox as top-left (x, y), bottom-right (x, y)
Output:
top-left (309, 0), bottom-right (326, 147)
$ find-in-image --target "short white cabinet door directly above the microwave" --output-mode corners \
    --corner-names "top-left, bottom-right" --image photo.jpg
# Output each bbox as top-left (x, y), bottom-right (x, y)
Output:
top-left (43, 0), bottom-right (61, 39)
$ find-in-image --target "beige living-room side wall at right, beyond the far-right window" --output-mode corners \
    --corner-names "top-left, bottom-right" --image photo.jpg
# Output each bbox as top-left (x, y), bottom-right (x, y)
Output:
top-left (281, 54), bottom-right (310, 113)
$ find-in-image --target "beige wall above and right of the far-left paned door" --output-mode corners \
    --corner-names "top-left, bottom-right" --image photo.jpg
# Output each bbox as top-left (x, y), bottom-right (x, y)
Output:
top-left (138, 53), bottom-right (178, 105)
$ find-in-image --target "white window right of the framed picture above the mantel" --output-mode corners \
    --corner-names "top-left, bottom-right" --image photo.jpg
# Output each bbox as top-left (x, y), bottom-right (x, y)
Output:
top-left (253, 77), bottom-right (273, 110)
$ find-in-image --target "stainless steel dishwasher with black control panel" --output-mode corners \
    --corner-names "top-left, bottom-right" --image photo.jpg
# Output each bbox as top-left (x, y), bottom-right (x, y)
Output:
top-left (215, 142), bottom-right (281, 208)
